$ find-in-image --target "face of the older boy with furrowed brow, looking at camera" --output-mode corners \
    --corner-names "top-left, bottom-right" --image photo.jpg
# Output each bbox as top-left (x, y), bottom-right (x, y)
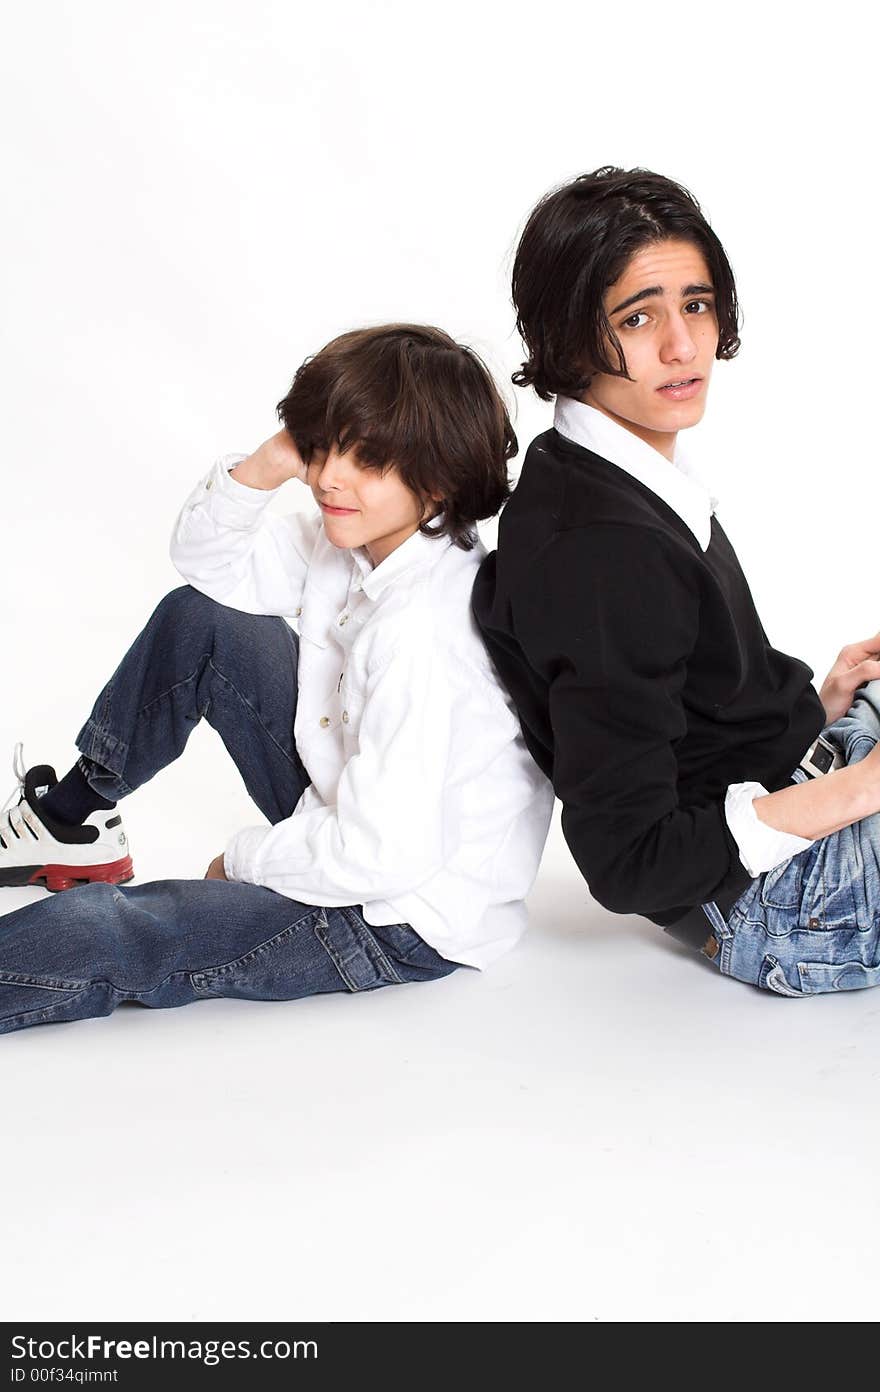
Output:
top-left (582, 239), bottom-right (718, 459)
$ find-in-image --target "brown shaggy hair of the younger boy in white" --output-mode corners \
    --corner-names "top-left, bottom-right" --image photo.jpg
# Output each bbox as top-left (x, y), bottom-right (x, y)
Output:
top-left (276, 324), bottom-right (517, 551)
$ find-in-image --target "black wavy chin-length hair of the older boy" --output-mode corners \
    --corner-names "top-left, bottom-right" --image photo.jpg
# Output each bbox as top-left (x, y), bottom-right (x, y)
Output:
top-left (512, 164), bottom-right (739, 401)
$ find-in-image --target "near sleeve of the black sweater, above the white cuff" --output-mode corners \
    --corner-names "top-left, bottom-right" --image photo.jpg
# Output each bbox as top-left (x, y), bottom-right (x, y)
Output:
top-left (514, 525), bottom-right (749, 917)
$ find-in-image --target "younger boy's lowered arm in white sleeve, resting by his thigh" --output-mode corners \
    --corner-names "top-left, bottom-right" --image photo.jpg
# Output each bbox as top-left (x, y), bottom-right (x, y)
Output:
top-left (224, 629), bottom-right (453, 906)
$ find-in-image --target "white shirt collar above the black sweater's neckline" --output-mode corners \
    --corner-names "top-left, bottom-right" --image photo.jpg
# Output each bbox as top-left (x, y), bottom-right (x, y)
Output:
top-left (553, 397), bottom-right (718, 551)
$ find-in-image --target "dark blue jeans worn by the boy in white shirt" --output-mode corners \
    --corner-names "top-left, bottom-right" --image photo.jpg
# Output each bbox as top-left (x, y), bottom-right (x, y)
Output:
top-left (0, 586), bottom-right (457, 1033)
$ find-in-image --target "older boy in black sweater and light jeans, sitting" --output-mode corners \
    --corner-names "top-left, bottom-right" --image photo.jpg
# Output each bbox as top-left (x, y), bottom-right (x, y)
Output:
top-left (473, 168), bottom-right (880, 995)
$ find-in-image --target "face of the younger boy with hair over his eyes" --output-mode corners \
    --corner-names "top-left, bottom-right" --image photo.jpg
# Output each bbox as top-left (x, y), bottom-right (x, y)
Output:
top-left (309, 445), bottom-right (434, 565)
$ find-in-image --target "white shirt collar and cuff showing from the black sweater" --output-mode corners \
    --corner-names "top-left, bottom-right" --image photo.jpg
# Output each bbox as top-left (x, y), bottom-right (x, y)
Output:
top-left (553, 397), bottom-right (813, 876)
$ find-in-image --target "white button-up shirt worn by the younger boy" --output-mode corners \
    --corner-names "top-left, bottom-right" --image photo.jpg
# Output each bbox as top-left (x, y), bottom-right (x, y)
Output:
top-left (171, 454), bottom-right (553, 967)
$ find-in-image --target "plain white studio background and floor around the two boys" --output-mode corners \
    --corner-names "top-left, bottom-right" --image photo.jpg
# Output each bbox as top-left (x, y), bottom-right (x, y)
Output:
top-left (0, 0), bottom-right (880, 1320)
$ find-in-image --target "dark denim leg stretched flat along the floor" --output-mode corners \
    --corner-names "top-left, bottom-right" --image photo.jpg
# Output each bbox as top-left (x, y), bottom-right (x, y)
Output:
top-left (0, 880), bottom-right (455, 1034)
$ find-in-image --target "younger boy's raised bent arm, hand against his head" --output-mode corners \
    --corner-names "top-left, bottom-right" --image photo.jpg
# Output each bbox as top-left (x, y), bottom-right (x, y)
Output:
top-left (171, 430), bottom-right (320, 614)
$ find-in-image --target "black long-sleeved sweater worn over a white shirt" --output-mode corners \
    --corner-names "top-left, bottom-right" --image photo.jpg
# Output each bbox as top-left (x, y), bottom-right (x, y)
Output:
top-left (473, 430), bottom-right (824, 926)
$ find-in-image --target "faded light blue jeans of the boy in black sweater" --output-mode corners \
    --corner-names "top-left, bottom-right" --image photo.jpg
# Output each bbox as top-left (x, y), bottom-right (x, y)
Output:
top-left (703, 682), bottom-right (880, 995)
